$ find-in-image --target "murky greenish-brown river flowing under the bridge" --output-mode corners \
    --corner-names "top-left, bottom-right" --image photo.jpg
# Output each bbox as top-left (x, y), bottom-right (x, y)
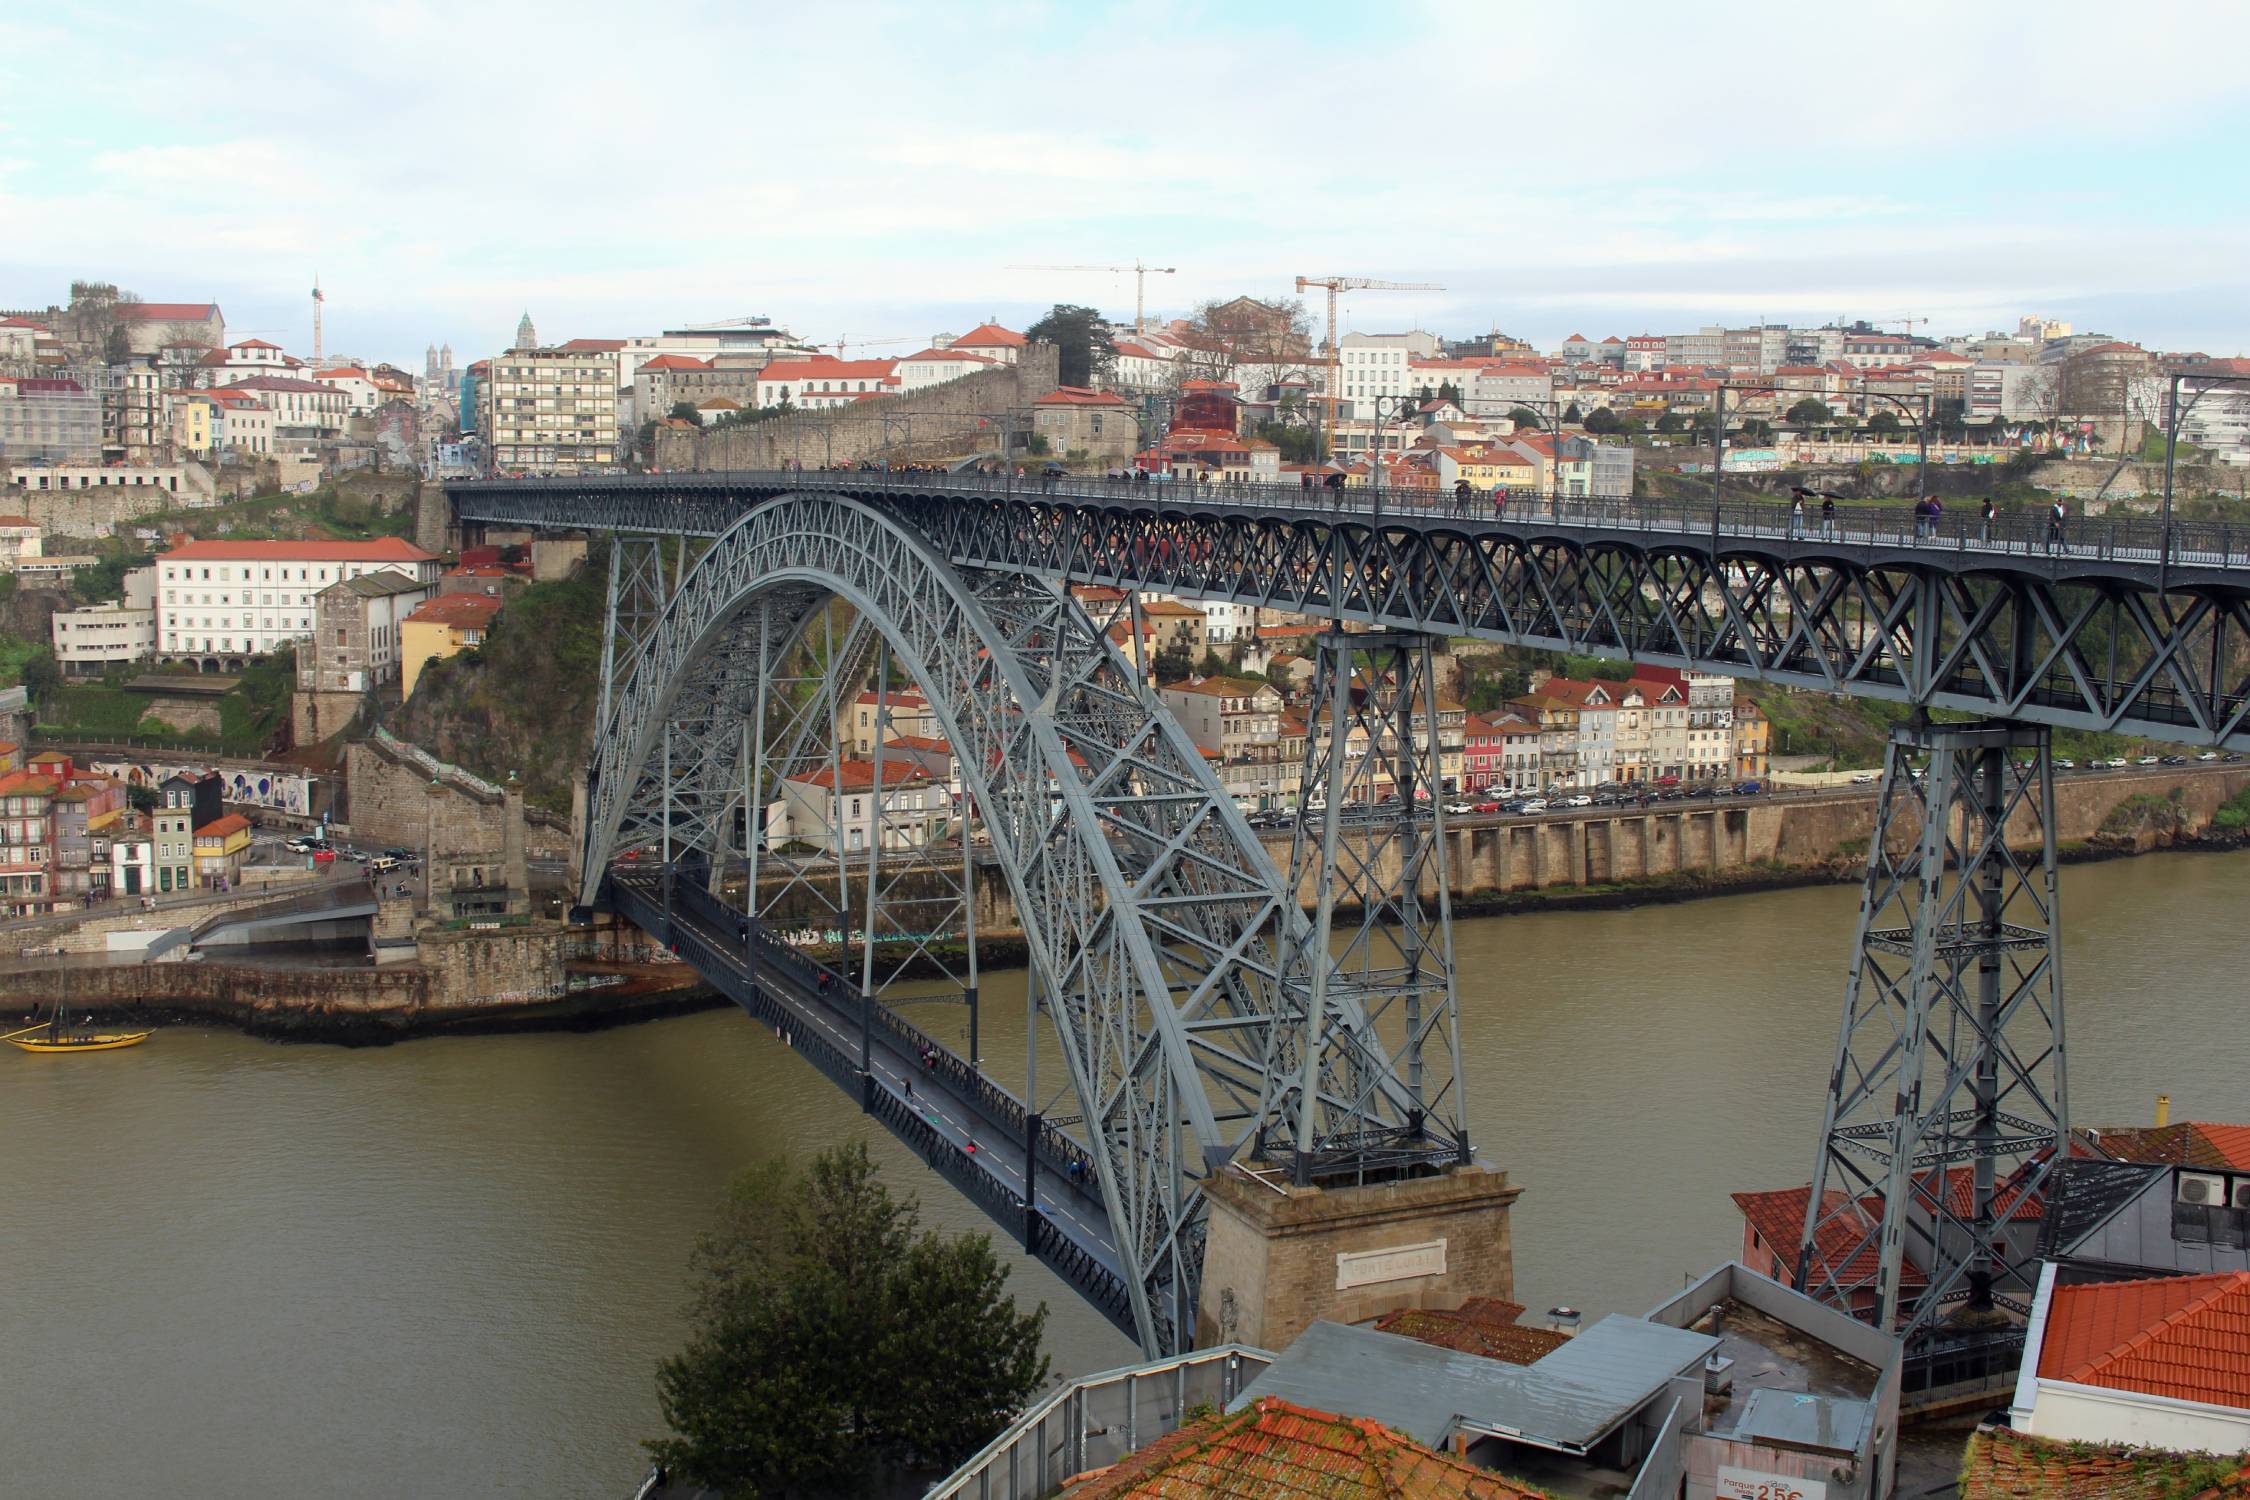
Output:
top-left (0, 852), bottom-right (2250, 1500)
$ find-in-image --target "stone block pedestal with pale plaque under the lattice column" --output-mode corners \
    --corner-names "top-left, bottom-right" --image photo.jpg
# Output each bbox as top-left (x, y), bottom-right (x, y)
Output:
top-left (1195, 1165), bottom-right (1523, 1349)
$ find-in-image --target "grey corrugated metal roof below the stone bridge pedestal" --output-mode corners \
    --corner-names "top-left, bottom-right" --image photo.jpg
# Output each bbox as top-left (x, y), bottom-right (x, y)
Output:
top-left (1235, 1318), bottom-right (1719, 1451)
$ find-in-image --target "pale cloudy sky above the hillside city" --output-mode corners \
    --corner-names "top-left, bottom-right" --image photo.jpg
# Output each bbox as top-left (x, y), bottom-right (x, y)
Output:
top-left (0, 0), bottom-right (2250, 369)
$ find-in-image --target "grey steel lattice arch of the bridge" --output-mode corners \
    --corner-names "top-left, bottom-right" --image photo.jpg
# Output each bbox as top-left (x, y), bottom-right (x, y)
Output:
top-left (581, 495), bottom-right (1415, 1352)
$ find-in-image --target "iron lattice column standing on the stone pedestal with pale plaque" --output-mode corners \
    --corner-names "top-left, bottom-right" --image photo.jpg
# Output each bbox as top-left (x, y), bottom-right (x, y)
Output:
top-left (1289, 627), bottom-right (1469, 1183)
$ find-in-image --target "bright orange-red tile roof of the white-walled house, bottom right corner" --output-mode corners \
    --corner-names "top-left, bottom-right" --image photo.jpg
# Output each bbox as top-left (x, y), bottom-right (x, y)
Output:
top-left (2039, 1271), bottom-right (2250, 1408)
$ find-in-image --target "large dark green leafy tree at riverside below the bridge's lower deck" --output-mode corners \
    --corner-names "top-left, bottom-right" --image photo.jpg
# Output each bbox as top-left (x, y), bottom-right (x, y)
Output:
top-left (646, 1142), bottom-right (1046, 1498)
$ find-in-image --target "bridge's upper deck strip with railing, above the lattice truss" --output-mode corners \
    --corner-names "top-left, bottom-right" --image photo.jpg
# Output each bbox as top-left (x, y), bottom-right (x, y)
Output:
top-left (446, 468), bottom-right (2250, 594)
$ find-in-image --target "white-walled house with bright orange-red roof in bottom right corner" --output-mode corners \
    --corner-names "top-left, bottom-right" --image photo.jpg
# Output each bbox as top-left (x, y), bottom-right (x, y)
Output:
top-left (2009, 1259), bottom-right (2250, 1455)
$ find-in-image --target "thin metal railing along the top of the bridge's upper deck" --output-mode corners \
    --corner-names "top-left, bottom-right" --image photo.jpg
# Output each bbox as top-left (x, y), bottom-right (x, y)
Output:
top-left (461, 468), bottom-right (2250, 567)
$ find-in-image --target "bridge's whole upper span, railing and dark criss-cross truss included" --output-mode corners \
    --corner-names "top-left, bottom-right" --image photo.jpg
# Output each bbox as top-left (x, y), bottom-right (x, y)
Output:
top-left (450, 472), bottom-right (2250, 749)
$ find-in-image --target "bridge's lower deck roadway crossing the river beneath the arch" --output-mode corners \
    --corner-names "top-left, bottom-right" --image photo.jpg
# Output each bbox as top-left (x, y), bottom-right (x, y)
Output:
top-left (605, 866), bottom-right (1136, 1334)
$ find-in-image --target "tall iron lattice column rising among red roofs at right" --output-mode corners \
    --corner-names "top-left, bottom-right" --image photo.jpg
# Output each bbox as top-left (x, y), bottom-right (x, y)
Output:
top-left (1796, 722), bottom-right (2070, 1345)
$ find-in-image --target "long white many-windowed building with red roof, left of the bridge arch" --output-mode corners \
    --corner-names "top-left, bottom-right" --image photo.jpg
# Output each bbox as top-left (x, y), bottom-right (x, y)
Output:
top-left (155, 537), bottom-right (441, 670)
